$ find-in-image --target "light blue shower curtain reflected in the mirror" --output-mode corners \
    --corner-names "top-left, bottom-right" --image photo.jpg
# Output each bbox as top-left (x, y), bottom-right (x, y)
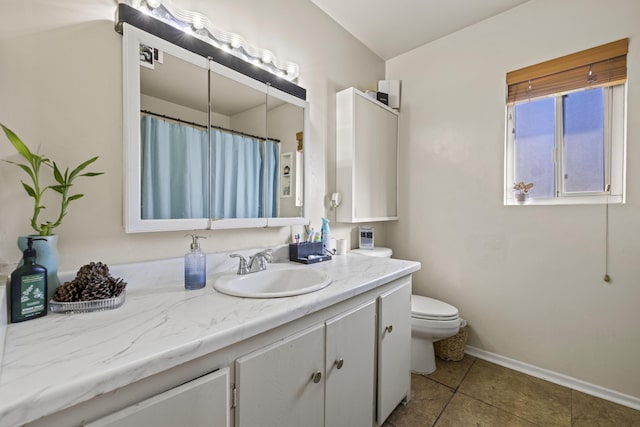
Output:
top-left (142, 115), bottom-right (279, 219)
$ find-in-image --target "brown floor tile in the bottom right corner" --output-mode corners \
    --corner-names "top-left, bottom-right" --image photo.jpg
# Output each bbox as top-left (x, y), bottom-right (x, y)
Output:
top-left (571, 390), bottom-right (640, 427)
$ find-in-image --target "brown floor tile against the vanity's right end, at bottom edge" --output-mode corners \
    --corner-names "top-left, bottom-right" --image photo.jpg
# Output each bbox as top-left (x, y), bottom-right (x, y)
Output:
top-left (385, 374), bottom-right (453, 427)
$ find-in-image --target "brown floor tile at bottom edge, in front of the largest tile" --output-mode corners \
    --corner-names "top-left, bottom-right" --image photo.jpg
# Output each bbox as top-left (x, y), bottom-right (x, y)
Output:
top-left (435, 393), bottom-right (537, 427)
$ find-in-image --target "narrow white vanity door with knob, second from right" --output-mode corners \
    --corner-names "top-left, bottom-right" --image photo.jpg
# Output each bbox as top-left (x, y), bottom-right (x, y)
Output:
top-left (324, 301), bottom-right (376, 427)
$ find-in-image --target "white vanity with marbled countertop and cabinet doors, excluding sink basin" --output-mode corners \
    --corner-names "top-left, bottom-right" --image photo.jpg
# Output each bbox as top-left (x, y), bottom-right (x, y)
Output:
top-left (0, 251), bottom-right (420, 426)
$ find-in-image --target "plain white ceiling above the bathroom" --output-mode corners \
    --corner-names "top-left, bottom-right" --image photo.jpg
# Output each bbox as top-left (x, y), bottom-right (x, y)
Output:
top-left (311, 0), bottom-right (529, 60)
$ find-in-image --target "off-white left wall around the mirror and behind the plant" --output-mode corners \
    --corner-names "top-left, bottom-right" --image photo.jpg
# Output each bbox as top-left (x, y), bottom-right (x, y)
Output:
top-left (0, 0), bottom-right (384, 275)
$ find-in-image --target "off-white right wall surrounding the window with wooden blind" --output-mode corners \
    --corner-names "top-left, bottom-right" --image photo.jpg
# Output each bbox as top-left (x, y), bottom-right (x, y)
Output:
top-left (386, 0), bottom-right (640, 397)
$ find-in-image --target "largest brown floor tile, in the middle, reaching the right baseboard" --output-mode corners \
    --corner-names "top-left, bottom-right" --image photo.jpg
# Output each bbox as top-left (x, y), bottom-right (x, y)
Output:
top-left (458, 359), bottom-right (571, 427)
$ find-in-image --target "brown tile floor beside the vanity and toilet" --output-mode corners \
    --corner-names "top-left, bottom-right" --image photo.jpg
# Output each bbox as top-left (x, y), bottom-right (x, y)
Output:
top-left (383, 355), bottom-right (640, 427)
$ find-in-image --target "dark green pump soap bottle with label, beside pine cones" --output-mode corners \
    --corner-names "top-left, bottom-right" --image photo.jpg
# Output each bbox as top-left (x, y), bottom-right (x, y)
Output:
top-left (7, 237), bottom-right (49, 323)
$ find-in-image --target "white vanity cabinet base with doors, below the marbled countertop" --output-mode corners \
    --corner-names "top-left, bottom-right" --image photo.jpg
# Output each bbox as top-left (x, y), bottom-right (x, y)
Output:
top-left (17, 274), bottom-right (411, 427)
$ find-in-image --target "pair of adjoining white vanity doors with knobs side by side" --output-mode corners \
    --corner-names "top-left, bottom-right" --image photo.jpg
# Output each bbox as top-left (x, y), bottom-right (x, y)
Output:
top-left (236, 301), bottom-right (376, 427)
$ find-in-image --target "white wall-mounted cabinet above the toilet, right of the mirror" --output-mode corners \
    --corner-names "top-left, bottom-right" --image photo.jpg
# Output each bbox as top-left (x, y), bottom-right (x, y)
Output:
top-left (336, 88), bottom-right (399, 223)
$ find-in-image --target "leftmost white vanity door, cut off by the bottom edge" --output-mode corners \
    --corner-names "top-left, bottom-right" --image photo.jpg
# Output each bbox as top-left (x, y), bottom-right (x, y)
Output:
top-left (86, 368), bottom-right (230, 427)
